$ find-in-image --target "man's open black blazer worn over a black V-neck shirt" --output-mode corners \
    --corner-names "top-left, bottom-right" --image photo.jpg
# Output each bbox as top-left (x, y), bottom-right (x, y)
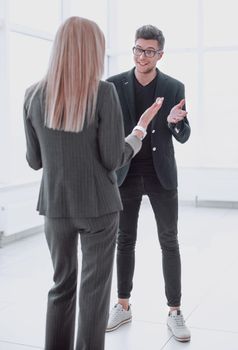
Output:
top-left (107, 68), bottom-right (190, 190)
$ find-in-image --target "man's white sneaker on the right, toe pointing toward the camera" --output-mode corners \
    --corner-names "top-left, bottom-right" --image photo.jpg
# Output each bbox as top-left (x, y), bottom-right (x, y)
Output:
top-left (167, 310), bottom-right (191, 342)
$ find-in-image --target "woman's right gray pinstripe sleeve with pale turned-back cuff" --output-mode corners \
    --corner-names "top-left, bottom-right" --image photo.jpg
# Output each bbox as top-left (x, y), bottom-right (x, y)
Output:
top-left (98, 83), bottom-right (142, 171)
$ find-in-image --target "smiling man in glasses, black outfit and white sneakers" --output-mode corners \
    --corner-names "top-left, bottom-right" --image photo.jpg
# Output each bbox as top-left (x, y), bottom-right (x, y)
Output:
top-left (107, 25), bottom-right (190, 341)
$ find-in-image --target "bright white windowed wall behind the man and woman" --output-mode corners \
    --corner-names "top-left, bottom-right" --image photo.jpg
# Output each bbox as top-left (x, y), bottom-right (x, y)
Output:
top-left (0, 0), bottom-right (238, 235)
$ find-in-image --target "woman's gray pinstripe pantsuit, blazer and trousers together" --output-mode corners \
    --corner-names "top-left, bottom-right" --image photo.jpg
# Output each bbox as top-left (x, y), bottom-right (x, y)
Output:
top-left (24, 81), bottom-right (141, 350)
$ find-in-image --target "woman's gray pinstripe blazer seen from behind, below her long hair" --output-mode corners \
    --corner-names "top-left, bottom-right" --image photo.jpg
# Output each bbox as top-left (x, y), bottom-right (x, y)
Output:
top-left (24, 81), bottom-right (141, 218)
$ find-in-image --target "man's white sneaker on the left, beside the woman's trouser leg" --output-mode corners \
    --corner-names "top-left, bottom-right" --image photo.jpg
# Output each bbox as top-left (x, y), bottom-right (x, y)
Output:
top-left (106, 304), bottom-right (132, 332)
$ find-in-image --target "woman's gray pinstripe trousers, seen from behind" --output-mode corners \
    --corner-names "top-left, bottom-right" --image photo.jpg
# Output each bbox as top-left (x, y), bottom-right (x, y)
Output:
top-left (45, 213), bottom-right (118, 350)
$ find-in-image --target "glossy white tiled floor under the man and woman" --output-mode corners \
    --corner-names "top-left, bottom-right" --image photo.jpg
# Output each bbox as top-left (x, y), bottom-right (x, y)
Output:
top-left (0, 199), bottom-right (238, 350)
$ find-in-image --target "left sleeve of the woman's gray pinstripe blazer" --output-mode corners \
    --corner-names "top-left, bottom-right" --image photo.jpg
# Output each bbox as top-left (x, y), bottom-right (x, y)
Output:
top-left (23, 95), bottom-right (42, 170)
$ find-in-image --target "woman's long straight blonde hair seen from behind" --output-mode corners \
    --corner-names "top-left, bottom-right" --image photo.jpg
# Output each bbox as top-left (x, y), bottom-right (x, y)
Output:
top-left (45, 17), bottom-right (105, 132)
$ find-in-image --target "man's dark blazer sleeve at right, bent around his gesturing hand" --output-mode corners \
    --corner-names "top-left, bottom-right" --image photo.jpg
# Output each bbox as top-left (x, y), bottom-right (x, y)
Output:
top-left (168, 83), bottom-right (191, 143)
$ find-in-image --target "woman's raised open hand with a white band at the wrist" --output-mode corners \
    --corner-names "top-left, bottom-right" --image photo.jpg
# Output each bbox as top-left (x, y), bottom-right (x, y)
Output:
top-left (133, 97), bottom-right (164, 140)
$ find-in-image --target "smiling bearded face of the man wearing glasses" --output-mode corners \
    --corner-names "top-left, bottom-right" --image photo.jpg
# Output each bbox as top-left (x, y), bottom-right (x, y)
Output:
top-left (133, 39), bottom-right (163, 74)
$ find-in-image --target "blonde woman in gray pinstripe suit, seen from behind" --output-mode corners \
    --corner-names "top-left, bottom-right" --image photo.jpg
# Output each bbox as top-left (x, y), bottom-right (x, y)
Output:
top-left (24, 17), bottom-right (163, 350)
